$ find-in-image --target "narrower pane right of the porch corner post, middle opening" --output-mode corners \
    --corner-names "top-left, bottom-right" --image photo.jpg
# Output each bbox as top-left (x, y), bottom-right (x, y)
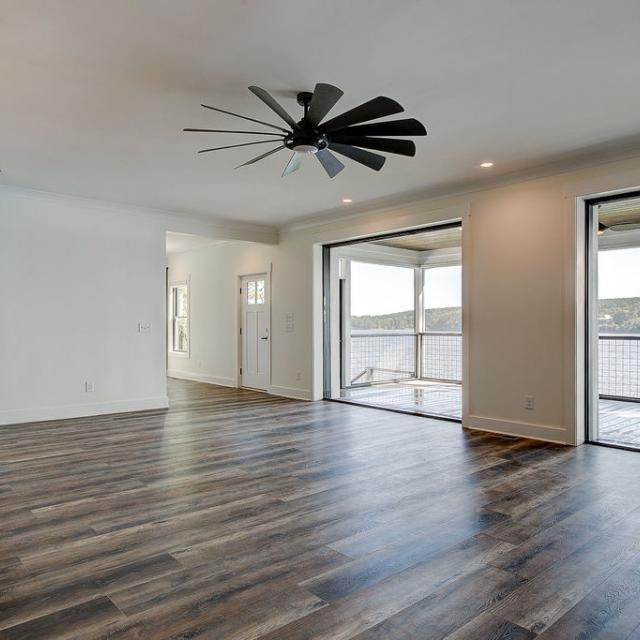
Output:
top-left (423, 266), bottom-right (462, 333)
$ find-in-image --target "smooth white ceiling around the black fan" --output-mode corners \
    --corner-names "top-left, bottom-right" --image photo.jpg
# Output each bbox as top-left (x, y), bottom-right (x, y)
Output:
top-left (0, 0), bottom-right (640, 224)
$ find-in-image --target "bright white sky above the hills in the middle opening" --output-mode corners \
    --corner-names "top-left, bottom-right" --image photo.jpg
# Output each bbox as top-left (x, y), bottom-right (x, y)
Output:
top-left (351, 261), bottom-right (462, 316)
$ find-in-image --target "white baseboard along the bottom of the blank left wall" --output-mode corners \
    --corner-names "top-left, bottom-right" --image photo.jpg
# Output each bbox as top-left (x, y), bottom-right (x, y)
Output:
top-left (0, 396), bottom-right (169, 425)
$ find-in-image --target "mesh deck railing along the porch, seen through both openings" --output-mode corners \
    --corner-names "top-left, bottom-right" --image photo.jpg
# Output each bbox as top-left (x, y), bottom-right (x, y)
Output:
top-left (346, 331), bottom-right (640, 399)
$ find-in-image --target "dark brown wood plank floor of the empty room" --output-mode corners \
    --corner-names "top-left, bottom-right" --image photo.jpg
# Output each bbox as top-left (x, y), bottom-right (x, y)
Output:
top-left (0, 380), bottom-right (640, 640)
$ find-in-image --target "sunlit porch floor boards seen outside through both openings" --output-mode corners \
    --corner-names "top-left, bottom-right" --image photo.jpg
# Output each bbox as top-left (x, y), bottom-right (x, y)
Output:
top-left (340, 380), bottom-right (640, 449)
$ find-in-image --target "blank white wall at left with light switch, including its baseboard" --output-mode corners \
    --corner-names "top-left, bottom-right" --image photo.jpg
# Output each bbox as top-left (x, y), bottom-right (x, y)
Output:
top-left (0, 191), bottom-right (167, 424)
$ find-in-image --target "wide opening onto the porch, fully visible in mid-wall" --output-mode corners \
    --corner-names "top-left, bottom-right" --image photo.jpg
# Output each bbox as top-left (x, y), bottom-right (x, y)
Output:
top-left (324, 223), bottom-right (462, 421)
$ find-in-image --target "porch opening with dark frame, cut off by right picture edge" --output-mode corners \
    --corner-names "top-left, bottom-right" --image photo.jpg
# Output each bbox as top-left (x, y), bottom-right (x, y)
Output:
top-left (586, 193), bottom-right (640, 450)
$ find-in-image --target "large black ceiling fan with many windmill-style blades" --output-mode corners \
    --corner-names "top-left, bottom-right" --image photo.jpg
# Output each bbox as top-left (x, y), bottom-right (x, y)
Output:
top-left (183, 82), bottom-right (427, 178)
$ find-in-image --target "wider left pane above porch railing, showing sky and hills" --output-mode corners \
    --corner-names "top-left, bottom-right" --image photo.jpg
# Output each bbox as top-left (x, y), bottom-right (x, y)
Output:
top-left (351, 260), bottom-right (415, 333)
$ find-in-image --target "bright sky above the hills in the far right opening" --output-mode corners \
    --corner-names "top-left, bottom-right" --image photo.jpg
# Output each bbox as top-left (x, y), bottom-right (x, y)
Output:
top-left (598, 247), bottom-right (640, 300)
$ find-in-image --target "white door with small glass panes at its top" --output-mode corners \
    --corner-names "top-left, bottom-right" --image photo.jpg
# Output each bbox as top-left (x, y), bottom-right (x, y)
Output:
top-left (240, 273), bottom-right (271, 390)
